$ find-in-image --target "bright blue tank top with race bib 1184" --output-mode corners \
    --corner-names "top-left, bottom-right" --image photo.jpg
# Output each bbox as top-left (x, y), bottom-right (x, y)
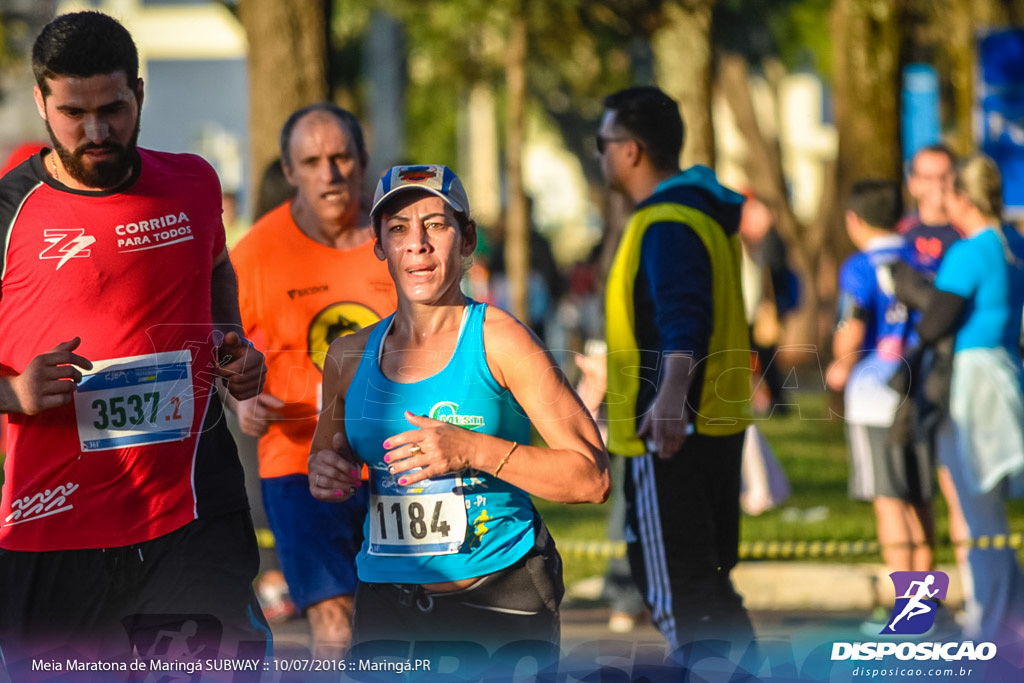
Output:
top-left (345, 300), bottom-right (534, 584)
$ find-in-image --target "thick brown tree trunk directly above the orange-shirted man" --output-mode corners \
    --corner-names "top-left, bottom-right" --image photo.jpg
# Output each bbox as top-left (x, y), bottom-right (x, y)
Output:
top-left (239, 0), bottom-right (329, 197)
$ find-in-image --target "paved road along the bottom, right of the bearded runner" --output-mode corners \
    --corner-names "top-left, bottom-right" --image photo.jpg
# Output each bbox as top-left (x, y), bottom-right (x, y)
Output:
top-left (270, 602), bottom-right (1024, 683)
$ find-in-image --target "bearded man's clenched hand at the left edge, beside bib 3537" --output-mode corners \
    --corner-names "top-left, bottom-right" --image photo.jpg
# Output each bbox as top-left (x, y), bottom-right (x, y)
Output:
top-left (0, 337), bottom-right (92, 415)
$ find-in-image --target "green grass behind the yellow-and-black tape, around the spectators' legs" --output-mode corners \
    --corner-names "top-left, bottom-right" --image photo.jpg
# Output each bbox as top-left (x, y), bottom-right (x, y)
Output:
top-left (537, 394), bottom-right (1024, 585)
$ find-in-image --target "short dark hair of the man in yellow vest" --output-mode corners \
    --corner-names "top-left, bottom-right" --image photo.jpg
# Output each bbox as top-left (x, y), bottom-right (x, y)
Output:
top-left (604, 86), bottom-right (685, 171)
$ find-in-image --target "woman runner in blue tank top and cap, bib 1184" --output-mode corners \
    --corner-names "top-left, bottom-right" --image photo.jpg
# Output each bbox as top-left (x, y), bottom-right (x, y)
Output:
top-left (309, 166), bottom-right (609, 663)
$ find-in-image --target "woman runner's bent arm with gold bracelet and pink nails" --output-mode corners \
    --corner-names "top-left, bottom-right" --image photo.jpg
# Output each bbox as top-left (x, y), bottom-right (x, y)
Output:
top-left (385, 307), bottom-right (611, 503)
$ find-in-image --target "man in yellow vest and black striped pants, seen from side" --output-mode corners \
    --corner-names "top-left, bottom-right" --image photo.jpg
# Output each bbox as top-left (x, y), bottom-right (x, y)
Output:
top-left (597, 87), bottom-right (753, 647)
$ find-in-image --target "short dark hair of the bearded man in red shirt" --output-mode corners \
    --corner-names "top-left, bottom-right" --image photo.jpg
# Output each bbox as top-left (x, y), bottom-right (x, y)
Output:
top-left (32, 11), bottom-right (138, 97)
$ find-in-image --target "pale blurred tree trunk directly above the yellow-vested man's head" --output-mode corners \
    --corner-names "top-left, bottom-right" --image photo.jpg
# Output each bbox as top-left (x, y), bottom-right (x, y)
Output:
top-left (651, 0), bottom-right (715, 168)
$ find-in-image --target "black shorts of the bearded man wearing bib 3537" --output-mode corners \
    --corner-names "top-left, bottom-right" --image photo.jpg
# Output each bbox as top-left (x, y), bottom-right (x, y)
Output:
top-left (0, 511), bottom-right (271, 680)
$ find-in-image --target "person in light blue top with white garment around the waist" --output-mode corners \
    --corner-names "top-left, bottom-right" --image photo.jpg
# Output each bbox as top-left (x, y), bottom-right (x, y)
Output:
top-left (918, 155), bottom-right (1024, 656)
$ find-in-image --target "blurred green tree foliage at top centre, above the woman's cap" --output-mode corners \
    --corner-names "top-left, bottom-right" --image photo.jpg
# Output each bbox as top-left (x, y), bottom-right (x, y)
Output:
top-left (332, 0), bottom-right (663, 179)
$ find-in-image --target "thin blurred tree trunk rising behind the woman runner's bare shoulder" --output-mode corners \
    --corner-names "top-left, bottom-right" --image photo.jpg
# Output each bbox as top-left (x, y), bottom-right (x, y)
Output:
top-left (505, 7), bottom-right (529, 323)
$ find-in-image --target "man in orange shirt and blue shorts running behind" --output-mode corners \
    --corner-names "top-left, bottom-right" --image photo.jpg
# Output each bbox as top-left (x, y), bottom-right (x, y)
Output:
top-left (231, 102), bottom-right (395, 658)
